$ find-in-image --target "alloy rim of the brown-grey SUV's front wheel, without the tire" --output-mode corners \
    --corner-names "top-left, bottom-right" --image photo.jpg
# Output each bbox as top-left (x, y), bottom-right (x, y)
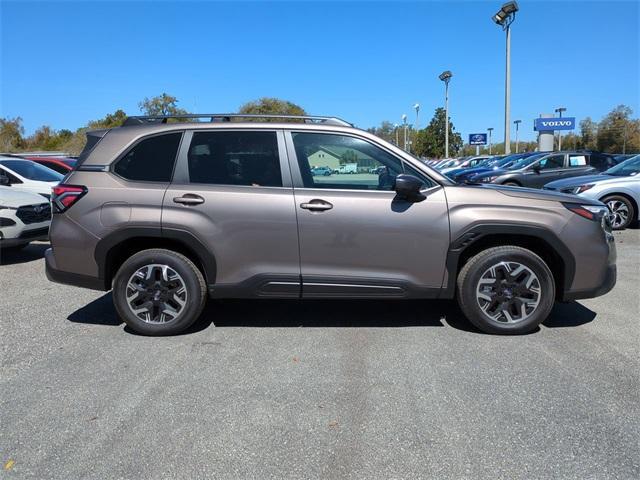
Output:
top-left (476, 261), bottom-right (542, 323)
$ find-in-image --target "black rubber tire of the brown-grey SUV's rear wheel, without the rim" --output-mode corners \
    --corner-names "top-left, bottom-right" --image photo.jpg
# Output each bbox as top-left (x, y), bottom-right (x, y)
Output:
top-left (113, 249), bottom-right (207, 336)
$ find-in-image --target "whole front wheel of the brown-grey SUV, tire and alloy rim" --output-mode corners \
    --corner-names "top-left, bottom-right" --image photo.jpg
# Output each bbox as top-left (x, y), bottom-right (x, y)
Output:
top-left (457, 246), bottom-right (555, 335)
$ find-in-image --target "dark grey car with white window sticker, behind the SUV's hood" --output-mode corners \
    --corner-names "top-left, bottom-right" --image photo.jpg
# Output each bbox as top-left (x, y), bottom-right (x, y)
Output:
top-left (470, 152), bottom-right (617, 188)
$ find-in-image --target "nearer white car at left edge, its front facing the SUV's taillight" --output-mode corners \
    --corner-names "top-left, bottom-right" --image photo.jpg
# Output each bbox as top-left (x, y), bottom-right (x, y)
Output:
top-left (0, 186), bottom-right (51, 249)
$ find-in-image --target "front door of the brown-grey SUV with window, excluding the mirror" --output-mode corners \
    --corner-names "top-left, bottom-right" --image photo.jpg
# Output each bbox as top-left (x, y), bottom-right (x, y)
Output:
top-left (287, 131), bottom-right (449, 297)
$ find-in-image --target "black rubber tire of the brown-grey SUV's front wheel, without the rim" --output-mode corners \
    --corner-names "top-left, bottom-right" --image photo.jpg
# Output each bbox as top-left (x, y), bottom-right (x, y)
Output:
top-left (457, 245), bottom-right (556, 335)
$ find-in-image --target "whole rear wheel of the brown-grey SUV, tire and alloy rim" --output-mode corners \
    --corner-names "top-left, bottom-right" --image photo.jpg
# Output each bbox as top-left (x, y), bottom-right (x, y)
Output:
top-left (113, 249), bottom-right (207, 335)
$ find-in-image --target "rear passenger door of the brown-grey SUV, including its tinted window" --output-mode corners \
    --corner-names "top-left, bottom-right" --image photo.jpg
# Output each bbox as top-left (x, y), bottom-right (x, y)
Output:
top-left (162, 129), bottom-right (300, 297)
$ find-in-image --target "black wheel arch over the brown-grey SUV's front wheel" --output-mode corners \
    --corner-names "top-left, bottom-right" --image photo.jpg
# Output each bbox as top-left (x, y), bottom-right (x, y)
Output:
top-left (442, 224), bottom-right (575, 299)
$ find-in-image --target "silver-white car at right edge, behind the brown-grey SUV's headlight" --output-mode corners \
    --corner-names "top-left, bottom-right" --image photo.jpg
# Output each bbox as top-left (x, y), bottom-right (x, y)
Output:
top-left (544, 155), bottom-right (640, 230)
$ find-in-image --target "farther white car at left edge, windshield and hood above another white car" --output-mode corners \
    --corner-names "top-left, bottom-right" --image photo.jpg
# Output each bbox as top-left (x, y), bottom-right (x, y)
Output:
top-left (0, 157), bottom-right (64, 199)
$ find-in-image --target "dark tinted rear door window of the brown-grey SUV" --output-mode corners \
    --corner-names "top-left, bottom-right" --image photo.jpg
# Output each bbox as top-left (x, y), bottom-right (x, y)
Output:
top-left (189, 131), bottom-right (282, 187)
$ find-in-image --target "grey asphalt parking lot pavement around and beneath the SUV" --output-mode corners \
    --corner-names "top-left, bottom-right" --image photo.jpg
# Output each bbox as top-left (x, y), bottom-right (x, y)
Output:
top-left (0, 229), bottom-right (640, 479)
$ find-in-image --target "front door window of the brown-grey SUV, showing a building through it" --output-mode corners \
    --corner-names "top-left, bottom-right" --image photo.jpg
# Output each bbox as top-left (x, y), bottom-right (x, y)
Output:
top-left (291, 132), bottom-right (428, 191)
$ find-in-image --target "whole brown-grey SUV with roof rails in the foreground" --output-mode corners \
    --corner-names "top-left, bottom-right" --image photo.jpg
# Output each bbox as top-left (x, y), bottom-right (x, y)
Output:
top-left (46, 114), bottom-right (616, 335)
